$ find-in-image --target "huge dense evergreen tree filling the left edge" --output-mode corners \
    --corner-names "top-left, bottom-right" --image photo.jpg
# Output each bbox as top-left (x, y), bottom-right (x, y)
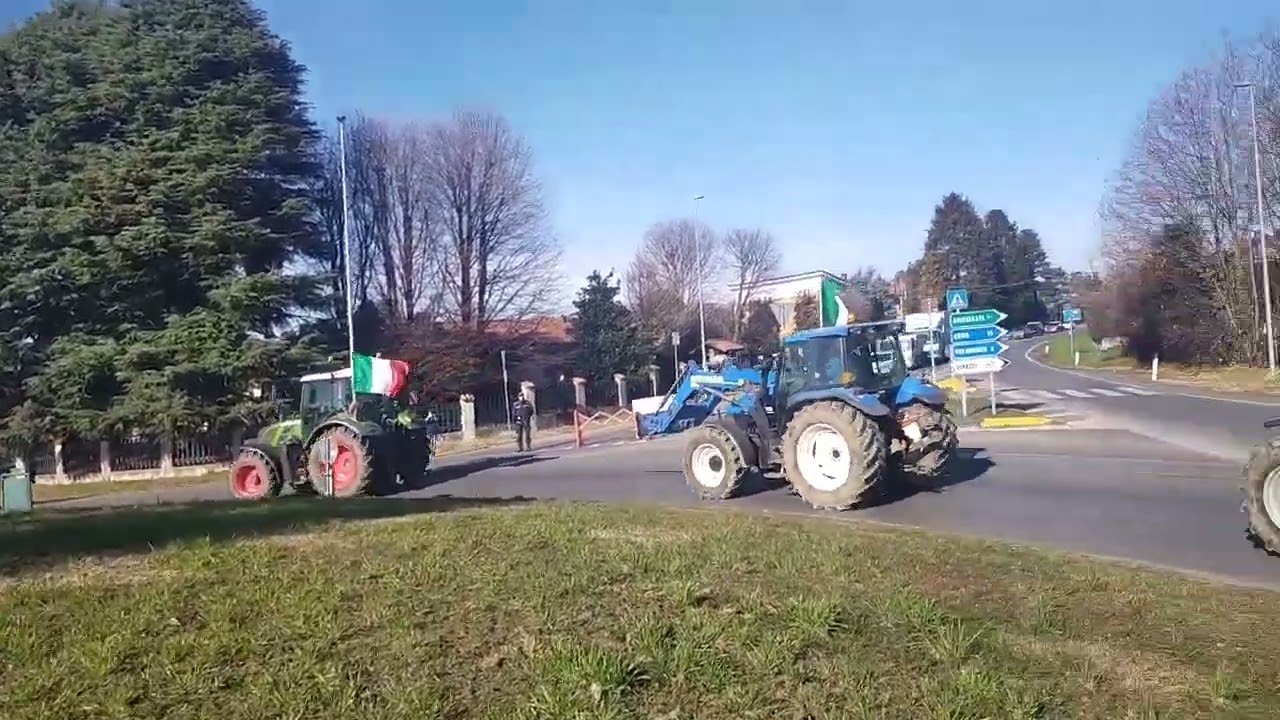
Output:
top-left (0, 0), bottom-right (316, 439)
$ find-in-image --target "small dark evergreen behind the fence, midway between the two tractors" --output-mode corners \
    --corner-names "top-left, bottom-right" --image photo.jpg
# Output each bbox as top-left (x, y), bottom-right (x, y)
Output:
top-left (573, 270), bottom-right (655, 379)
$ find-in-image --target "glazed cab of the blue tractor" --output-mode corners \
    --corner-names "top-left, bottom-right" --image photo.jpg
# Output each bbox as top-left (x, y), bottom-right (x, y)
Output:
top-left (777, 320), bottom-right (908, 407)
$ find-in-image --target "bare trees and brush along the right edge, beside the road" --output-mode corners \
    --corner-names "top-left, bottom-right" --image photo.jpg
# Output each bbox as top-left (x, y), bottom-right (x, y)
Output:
top-left (1084, 29), bottom-right (1280, 365)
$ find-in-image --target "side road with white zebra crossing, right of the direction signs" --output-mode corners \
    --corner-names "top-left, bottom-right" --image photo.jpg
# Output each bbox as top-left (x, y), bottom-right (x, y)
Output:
top-left (962, 338), bottom-right (1280, 464)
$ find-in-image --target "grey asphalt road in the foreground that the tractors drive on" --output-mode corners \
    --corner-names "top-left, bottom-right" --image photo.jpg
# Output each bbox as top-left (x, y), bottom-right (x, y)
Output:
top-left (47, 429), bottom-right (1280, 588)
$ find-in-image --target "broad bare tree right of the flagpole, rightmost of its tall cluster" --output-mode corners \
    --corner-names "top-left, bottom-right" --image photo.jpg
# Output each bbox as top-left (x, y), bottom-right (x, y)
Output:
top-left (428, 111), bottom-right (561, 329)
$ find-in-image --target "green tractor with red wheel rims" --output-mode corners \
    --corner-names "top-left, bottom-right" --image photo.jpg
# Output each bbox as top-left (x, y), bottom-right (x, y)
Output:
top-left (230, 368), bottom-right (436, 500)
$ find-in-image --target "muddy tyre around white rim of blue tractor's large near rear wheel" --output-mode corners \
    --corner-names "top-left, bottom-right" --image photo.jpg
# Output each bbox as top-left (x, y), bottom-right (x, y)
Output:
top-left (782, 401), bottom-right (888, 510)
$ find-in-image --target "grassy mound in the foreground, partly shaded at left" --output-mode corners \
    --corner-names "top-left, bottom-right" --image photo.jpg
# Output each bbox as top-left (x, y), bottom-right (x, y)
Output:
top-left (0, 500), bottom-right (1280, 720)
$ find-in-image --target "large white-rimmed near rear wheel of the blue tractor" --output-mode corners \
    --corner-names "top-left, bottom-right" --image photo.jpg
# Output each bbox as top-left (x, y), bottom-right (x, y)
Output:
top-left (782, 401), bottom-right (887, 510)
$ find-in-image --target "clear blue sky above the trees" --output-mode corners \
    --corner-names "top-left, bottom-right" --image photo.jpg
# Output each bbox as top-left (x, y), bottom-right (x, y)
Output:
top-left (7, 0), bottom-right (1280, 284)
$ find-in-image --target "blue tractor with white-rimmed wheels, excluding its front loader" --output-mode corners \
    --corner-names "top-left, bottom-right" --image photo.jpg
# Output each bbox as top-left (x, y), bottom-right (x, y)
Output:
top-left (684, 322), bottom-right (959, 510)
